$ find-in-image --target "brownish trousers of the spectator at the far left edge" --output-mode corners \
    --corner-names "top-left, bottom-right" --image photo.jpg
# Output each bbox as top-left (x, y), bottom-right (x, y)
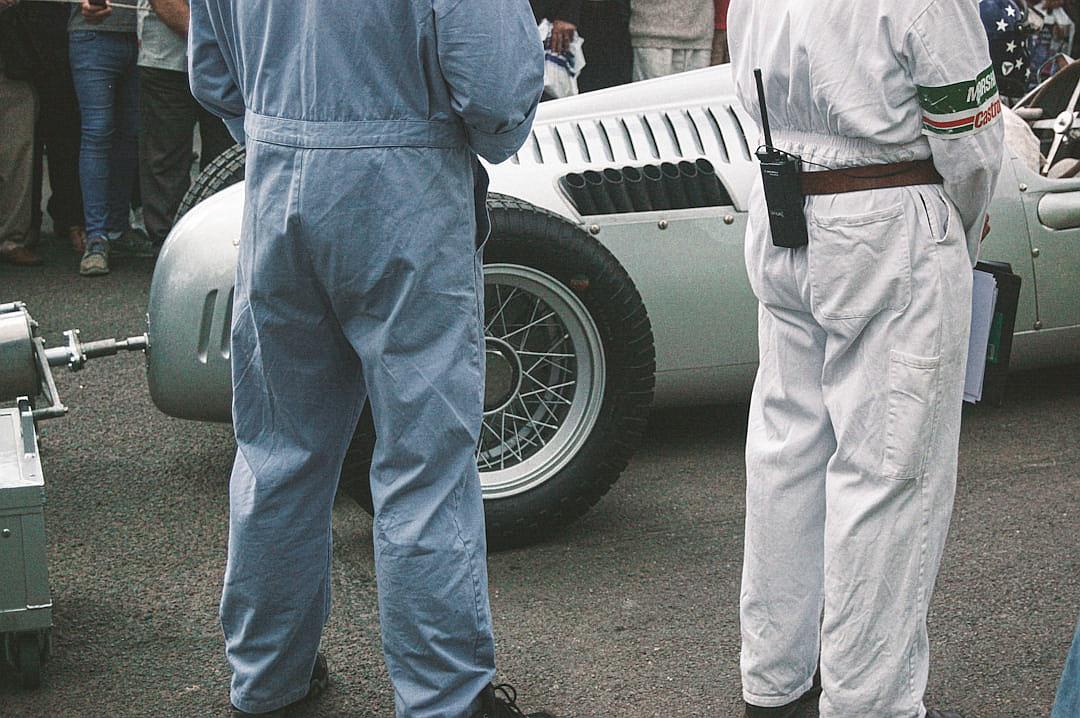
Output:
top-left (0, 71), bottom-right (37, 248)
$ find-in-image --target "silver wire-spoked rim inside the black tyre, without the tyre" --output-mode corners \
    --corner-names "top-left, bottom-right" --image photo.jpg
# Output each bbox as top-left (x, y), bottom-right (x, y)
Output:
top-left (476, 263), bottom-right (606, 499)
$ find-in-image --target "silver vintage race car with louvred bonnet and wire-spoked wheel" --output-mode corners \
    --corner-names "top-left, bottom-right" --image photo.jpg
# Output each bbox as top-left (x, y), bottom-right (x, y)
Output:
top-left (143, 66), bottom-right (1080, 546)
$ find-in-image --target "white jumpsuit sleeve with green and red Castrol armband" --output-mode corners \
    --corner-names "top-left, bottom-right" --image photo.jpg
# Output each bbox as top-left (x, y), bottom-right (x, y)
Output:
top-left (908, 0), bottom-right (1004, 262)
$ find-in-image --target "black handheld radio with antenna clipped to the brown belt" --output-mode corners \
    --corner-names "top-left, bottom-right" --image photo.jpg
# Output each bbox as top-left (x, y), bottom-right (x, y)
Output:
top-left (754, 69), bottom-right (809, 249)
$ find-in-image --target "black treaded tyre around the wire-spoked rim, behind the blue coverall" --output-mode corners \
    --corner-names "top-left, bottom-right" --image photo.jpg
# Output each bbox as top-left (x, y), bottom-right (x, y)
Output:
top-left (341, 194), bottom-right (656, 548)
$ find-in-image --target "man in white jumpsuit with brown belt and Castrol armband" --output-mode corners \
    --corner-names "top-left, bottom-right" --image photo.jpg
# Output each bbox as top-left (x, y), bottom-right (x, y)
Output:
top-left (728, 0), bottom-right (1002, 718)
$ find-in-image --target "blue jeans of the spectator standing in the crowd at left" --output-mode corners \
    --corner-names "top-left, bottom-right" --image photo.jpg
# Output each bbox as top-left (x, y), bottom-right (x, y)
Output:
top-left (68, 30), bottom-right (138, 238)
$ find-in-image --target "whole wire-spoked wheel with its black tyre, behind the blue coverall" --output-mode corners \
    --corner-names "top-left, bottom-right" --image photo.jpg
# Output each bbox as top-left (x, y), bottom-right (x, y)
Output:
top-left (341, 194), bottom-right (656, 548)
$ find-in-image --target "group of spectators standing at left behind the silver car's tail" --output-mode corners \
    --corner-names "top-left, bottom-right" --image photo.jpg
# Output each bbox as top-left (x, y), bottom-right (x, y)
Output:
top-left (0, 0), bottom-right (232, 276)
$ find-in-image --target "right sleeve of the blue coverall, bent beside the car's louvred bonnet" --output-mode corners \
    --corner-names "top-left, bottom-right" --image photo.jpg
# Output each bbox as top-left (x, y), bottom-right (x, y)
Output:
top-left (434, 0), bottom-right (543, 163)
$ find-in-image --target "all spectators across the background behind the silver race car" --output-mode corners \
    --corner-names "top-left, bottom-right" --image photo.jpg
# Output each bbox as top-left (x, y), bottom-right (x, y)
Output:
top-left (6, 0), bottom-right (1080, 276)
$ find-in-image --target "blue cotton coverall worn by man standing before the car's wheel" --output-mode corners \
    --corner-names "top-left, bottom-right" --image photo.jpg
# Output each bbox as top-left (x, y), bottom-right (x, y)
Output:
top-left (189, 0), bottom-right (543, 718)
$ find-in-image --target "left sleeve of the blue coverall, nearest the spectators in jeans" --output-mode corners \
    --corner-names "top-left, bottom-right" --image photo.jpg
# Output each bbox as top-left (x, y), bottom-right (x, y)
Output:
top-left (188, 0), bottom-right (244, 144)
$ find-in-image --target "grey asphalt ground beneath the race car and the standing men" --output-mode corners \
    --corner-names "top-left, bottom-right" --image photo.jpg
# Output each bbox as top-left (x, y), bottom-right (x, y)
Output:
top-left (0, 236), bottom-right (1080, 718)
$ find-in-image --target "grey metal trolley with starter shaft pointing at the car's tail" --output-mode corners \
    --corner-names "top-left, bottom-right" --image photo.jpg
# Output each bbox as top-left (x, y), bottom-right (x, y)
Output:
top-left (0, 302), bottom-right (148, 688)
